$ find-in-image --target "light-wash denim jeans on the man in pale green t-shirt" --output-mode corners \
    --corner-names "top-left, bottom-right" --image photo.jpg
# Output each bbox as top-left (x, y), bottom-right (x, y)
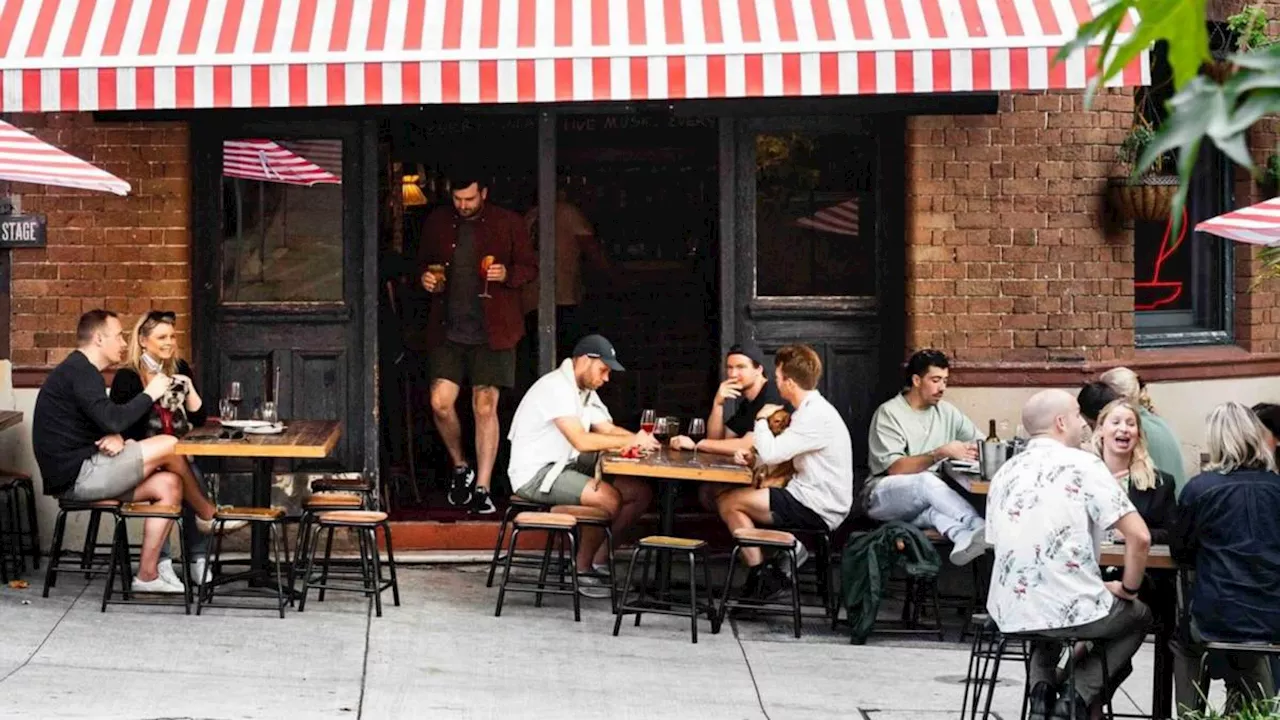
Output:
top-left (867, 473), bottom-right (982, 539)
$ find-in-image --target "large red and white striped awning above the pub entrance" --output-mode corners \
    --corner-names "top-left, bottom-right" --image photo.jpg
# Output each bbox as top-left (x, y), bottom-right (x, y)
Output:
top-left (0, 0), bottom-right (1149, 111)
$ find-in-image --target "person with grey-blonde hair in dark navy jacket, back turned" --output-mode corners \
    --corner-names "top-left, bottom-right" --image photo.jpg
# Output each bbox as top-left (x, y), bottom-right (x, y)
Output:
top-left (1170, 402), bottom-right (1280, 712)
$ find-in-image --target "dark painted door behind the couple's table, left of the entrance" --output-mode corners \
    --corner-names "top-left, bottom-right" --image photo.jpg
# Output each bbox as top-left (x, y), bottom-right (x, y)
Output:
top-left (192, 122), bottom-right (379, 497)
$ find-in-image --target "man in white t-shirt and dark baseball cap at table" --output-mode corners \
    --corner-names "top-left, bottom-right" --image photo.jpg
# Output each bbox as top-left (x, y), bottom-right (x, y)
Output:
top-left (507, 334), bottom-right (658, 597)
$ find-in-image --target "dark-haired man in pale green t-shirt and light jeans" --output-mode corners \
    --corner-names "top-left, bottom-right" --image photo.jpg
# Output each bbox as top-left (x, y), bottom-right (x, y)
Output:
top-left (859, 350), bottom-right (987, 565)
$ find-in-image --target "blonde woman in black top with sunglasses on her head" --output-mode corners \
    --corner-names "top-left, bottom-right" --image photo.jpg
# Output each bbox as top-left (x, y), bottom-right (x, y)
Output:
top-left (111, 310), bottom-right (233, 584)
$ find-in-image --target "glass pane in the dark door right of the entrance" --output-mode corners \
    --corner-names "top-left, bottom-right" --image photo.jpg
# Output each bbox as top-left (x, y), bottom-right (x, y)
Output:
top-left (755, 132), bottom-right (876, 297)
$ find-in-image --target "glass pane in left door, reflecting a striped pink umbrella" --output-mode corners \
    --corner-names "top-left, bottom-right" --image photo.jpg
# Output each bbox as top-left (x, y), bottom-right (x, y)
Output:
top-left (221, 138), bottom-right (343, 302)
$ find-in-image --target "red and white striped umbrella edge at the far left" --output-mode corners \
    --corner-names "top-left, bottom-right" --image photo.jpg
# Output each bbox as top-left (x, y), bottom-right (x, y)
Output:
top-left (0, 120), bottom-right (132, 195)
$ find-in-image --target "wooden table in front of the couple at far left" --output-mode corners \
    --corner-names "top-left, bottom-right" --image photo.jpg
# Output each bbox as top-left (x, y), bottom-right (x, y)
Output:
top-left (174, 420), bottom-right (342, 584)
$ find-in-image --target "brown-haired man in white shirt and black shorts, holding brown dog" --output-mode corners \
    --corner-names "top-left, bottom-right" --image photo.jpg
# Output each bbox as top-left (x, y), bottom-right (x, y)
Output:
top-left (717, 345), bottom-right (854, 598)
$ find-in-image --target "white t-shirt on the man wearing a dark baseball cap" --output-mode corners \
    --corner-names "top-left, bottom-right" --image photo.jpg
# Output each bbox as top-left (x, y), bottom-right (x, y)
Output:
top-left (507, 359), bottom-right (613, 491)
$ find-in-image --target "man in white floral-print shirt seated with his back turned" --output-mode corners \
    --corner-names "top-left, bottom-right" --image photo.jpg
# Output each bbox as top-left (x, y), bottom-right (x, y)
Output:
top-left (987, 389), bottom-right (1151, 720)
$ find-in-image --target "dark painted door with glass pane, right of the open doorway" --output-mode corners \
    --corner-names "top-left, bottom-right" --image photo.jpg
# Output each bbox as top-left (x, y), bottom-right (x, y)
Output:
top-left (721, 117), bottom-right (904, 468)
